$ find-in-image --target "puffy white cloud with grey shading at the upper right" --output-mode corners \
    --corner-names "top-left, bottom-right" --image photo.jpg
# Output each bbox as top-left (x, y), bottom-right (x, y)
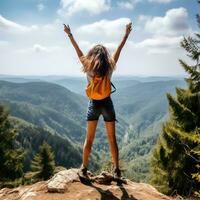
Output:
top-left (145, 7), bottom-right (189, 35)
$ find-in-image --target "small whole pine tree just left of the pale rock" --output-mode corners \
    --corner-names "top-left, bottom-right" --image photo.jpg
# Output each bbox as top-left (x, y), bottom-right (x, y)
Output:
top-left (31, 142), bottom-right (55, 180)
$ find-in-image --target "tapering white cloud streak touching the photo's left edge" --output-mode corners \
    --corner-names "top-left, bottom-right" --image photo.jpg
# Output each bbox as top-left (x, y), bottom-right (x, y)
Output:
top-left (0, 15), bottom-right (38, 33)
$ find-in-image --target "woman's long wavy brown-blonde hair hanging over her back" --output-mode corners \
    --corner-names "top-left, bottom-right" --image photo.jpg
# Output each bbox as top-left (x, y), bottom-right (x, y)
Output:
top-left (82, 44), bottom-right (115, 76)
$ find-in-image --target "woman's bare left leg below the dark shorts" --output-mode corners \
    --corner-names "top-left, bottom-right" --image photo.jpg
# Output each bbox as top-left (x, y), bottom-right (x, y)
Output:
top-left (83, 120), bottom-right (98, 167)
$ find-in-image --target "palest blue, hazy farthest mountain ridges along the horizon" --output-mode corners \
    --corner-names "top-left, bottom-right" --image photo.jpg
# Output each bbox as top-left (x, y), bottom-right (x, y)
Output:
top-left (0, 74), bottom-right (180, 95)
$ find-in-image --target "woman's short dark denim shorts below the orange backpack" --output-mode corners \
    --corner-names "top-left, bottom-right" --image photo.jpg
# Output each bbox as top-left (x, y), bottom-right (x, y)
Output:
top-left (86, 96), bottom-right (117, 122)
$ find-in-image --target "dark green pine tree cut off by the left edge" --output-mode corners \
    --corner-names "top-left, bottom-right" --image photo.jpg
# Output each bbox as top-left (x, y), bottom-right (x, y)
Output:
top-left (0, 105), bottom-right (25, 183)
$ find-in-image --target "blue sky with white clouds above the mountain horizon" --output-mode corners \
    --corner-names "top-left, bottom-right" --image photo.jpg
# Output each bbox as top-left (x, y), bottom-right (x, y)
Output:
top-left (0, 0), bottom-right (199, 76)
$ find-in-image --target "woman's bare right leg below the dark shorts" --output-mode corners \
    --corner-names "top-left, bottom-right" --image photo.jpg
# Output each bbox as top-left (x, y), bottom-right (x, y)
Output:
top-left (105, 121), bottom-right (119, 168)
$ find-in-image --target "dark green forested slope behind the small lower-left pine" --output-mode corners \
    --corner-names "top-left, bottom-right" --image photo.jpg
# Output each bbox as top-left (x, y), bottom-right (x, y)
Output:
top-left (10, 117), bottom-right (85, 172)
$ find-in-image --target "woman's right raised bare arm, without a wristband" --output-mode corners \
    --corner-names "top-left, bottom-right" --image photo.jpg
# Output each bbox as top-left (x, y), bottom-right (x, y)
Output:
top-left (113, 22), bottom-right (132, 63)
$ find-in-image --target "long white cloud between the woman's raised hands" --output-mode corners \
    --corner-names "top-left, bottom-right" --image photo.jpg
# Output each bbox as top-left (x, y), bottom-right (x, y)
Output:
top-left (76, 18), bottom-right (130, 40)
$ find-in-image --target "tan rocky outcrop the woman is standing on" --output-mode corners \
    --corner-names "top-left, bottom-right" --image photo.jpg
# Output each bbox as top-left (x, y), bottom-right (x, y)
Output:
top-left (0, 169), bottom-right (171, 200)
